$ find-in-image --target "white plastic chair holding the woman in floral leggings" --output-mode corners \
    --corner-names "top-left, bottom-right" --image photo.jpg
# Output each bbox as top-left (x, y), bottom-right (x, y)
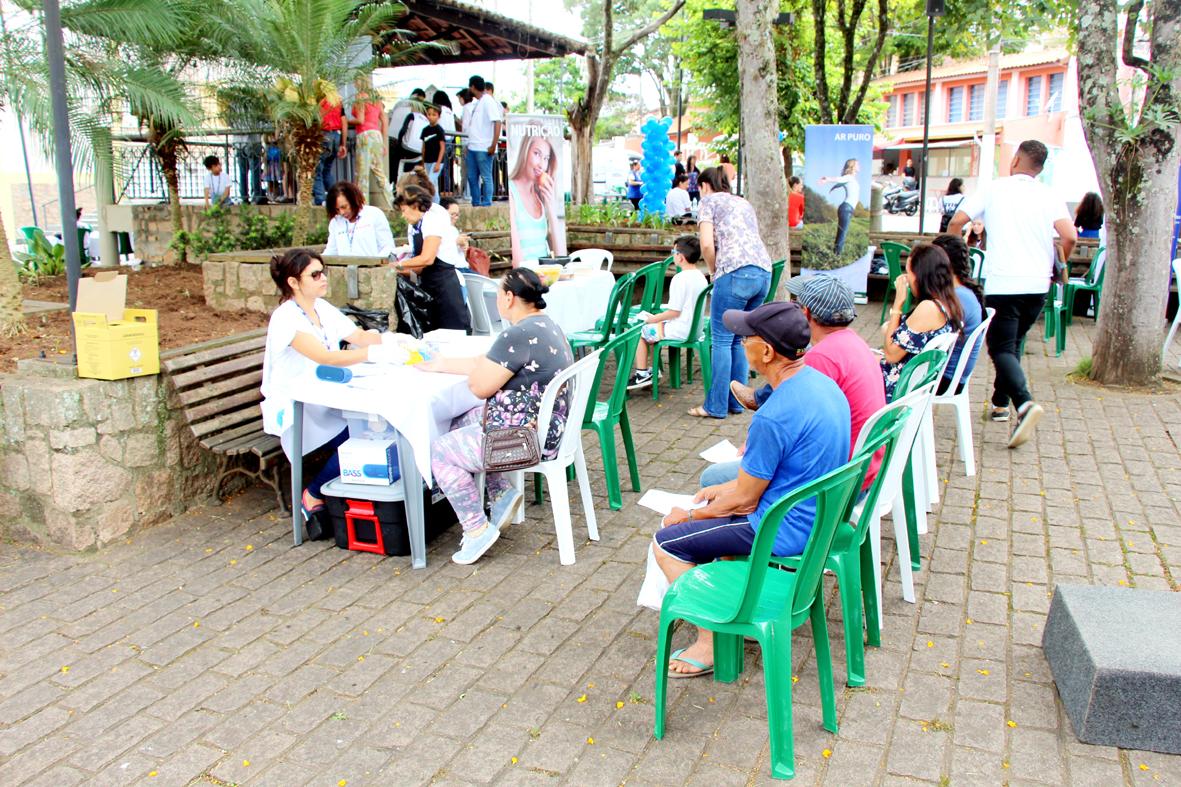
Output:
top-left (515, 350), bottom-right (602, 566)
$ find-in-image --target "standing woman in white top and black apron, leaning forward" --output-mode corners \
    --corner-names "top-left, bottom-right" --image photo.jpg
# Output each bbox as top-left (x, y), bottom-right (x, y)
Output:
top-left (393, 186), bottom-right (471, 333)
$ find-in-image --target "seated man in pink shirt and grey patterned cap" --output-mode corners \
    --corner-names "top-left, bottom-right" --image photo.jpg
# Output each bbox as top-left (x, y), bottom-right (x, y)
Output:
top-left (702, 274), bottom-right (886, 489)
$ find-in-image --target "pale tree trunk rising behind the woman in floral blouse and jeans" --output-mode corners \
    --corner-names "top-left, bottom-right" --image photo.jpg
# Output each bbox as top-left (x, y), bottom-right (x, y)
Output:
top-left (736, 0), bottom-right (791, 281)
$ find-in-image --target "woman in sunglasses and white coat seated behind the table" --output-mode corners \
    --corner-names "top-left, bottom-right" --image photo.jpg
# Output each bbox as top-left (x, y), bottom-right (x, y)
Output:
top-left (262, 248), bottom-right (381, 529)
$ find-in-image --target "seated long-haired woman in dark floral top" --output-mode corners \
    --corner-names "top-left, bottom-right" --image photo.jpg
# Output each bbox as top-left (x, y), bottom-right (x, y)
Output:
top-left (881, 243), bottom-right (964, 402)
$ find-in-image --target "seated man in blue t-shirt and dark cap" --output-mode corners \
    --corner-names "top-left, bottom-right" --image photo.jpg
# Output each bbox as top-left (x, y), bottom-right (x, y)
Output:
top-left (653, 301), bottom-right (850, 677)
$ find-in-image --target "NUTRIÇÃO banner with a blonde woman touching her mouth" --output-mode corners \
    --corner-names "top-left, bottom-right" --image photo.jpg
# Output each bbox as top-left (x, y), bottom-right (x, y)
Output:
top-left (505, 115), bottom-right (570, 266)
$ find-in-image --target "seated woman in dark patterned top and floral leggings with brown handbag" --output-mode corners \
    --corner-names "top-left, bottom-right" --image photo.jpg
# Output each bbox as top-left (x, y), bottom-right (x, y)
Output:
top-left (418, 268), bottom-right (581, 565)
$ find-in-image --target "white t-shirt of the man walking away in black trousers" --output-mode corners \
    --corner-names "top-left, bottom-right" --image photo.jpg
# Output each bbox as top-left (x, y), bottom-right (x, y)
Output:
top-left (959, 175), bottom-right (1074, 295)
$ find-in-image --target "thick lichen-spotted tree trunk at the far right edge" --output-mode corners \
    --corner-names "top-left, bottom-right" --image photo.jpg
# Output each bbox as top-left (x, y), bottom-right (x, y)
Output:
top-left (1078, 0), bottom-right (1181, 385)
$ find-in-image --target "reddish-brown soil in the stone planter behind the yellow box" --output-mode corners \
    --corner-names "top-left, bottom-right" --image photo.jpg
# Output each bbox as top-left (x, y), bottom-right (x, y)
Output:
top-left (8, 265), bottom-right (268, 372)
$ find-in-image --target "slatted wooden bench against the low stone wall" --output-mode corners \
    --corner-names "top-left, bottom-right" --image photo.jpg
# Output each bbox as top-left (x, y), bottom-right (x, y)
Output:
top-left (161, 329), bottom-right (288, 510)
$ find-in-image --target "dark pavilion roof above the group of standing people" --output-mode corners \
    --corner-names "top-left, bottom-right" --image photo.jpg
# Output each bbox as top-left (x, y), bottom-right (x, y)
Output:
top-left (380, 0), bottom-right (587, 64)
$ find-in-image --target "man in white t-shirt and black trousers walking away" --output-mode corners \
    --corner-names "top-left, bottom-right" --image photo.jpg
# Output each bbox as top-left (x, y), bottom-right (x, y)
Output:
top-left (947, 139), bottom-right (1078, 448)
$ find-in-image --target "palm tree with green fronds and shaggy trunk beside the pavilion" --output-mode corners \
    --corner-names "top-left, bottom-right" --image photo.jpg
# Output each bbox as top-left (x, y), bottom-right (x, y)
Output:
top-left (237, 0), bottom-right (417, 245)
